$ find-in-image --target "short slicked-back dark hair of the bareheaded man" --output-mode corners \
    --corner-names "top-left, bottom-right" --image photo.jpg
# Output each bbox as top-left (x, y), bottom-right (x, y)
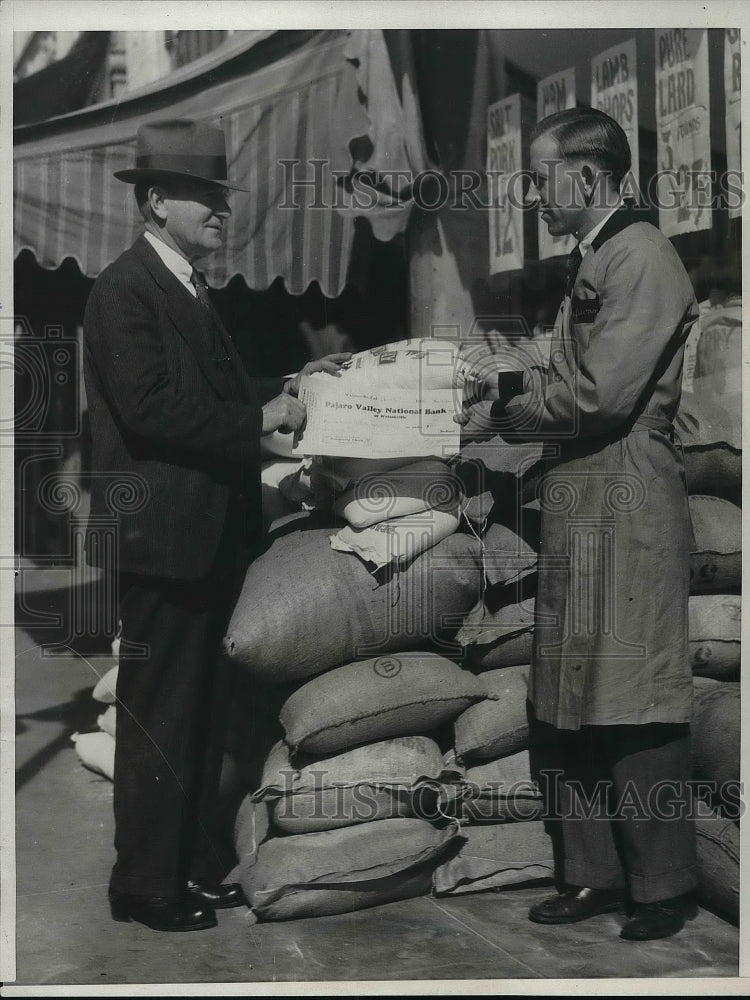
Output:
top-left (531, 108), bottom-right (632, 187)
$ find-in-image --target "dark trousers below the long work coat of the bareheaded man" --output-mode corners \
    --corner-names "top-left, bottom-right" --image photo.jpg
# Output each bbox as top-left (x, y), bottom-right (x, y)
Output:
top-left (532, 721), bottom-right (697, 903)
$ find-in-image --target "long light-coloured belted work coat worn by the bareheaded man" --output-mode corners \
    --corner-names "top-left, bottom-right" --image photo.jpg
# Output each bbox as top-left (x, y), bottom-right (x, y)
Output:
top-left (506, 206), bottom-right (698, 729)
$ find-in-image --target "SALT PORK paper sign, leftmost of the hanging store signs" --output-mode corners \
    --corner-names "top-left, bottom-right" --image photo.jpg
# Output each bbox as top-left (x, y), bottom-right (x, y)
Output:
top-left (487, 94), bottom-right (523, 274)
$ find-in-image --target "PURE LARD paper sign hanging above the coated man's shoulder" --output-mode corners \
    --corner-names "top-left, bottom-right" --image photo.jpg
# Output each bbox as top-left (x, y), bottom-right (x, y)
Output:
top-left (655, 28), bottom-right (711, 236)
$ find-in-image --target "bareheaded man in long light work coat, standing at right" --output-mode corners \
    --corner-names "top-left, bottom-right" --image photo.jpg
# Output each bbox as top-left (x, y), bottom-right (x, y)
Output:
top-left (468, 108), bottom-right (698, 940)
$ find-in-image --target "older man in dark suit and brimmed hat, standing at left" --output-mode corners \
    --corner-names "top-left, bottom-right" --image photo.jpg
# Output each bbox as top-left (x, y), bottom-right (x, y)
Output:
top-left (84, 120), bottom-right (347, 931)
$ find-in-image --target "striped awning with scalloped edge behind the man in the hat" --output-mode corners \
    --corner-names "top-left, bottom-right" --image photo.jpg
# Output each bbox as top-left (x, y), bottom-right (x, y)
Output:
top-left (14, 31), bottom-right (418, 297)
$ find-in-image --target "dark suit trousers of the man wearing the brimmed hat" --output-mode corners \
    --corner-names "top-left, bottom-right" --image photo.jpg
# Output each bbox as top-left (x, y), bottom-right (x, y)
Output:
top-left (110, 530), bottom-right (245, 896)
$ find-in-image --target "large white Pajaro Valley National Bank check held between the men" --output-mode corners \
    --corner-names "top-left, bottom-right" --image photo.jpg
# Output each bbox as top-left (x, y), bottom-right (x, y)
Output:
top-left (292, 340), bottom-right (461, 458)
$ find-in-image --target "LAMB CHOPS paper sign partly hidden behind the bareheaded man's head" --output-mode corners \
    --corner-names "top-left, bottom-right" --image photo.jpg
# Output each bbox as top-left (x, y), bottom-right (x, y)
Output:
top-left (591, 38), bottom-right (639, 191)
